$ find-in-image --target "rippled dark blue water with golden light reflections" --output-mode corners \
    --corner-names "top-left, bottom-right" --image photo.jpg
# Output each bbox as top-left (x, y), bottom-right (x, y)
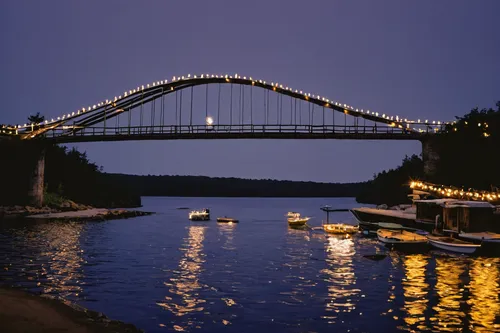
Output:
top-left (0, 198), bottom-right (500, 332)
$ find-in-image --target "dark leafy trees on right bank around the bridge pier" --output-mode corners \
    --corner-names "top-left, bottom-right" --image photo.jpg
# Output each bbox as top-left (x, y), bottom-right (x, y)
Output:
top-left (356, 102), bottom-right (500, 205)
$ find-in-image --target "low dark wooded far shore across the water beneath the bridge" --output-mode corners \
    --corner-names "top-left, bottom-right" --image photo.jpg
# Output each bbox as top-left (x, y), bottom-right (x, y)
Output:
top-left (102, 174), bottom-right (365, 197)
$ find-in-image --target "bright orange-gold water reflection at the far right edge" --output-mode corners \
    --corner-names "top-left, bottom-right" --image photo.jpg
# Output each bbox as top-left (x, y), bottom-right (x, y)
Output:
top-left (467, 258), bottom-right (500, 332)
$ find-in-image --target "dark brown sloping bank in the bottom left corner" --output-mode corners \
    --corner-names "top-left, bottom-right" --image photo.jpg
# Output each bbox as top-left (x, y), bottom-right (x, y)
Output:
top-left (0, 288), bottom-right (143, 333)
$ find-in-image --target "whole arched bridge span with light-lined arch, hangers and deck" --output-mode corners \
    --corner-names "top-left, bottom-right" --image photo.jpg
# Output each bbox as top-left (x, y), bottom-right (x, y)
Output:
top-left (2, 74), bottom-right (445, 143)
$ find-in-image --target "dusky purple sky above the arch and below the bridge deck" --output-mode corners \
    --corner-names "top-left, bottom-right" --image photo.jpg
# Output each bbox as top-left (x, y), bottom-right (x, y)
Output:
top-left (0, 0), bottom-right (500, 182)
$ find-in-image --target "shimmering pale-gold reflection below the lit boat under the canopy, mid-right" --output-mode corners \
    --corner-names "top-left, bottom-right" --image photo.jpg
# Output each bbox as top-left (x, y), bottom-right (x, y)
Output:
top-left (321, 236), bottom-right (361, 323)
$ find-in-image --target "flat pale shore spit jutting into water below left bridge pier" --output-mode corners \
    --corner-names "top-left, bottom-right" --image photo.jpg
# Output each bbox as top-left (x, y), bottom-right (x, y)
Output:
top-left (25, 208), bottom-right (152, 221)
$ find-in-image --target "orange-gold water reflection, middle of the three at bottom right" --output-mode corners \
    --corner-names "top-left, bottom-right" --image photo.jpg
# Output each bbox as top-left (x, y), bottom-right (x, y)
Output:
top-left (430, 258), bottom-right (466, 332)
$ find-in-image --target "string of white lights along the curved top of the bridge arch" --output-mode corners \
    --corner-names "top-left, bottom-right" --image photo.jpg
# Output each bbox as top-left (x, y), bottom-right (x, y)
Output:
top-left (9, 74), bottom-right (449, 134)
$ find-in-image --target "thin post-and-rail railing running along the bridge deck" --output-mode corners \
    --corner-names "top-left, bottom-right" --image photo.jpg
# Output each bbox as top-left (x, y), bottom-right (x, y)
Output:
top-left (45, 124), bottom-right (418, 138)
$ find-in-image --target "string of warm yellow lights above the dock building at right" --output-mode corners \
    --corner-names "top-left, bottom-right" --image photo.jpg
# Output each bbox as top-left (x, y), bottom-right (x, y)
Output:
top-left (410, 181), bottom-right (500, 201)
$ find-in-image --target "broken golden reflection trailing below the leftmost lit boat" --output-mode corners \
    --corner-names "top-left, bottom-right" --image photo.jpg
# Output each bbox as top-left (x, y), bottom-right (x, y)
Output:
top-left (157, 225), bottom-right (206, 329)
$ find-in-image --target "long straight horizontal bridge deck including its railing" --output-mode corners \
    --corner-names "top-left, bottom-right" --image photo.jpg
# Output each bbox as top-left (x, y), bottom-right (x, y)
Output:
top-left (38, 125), bottom-right (425, 143)
